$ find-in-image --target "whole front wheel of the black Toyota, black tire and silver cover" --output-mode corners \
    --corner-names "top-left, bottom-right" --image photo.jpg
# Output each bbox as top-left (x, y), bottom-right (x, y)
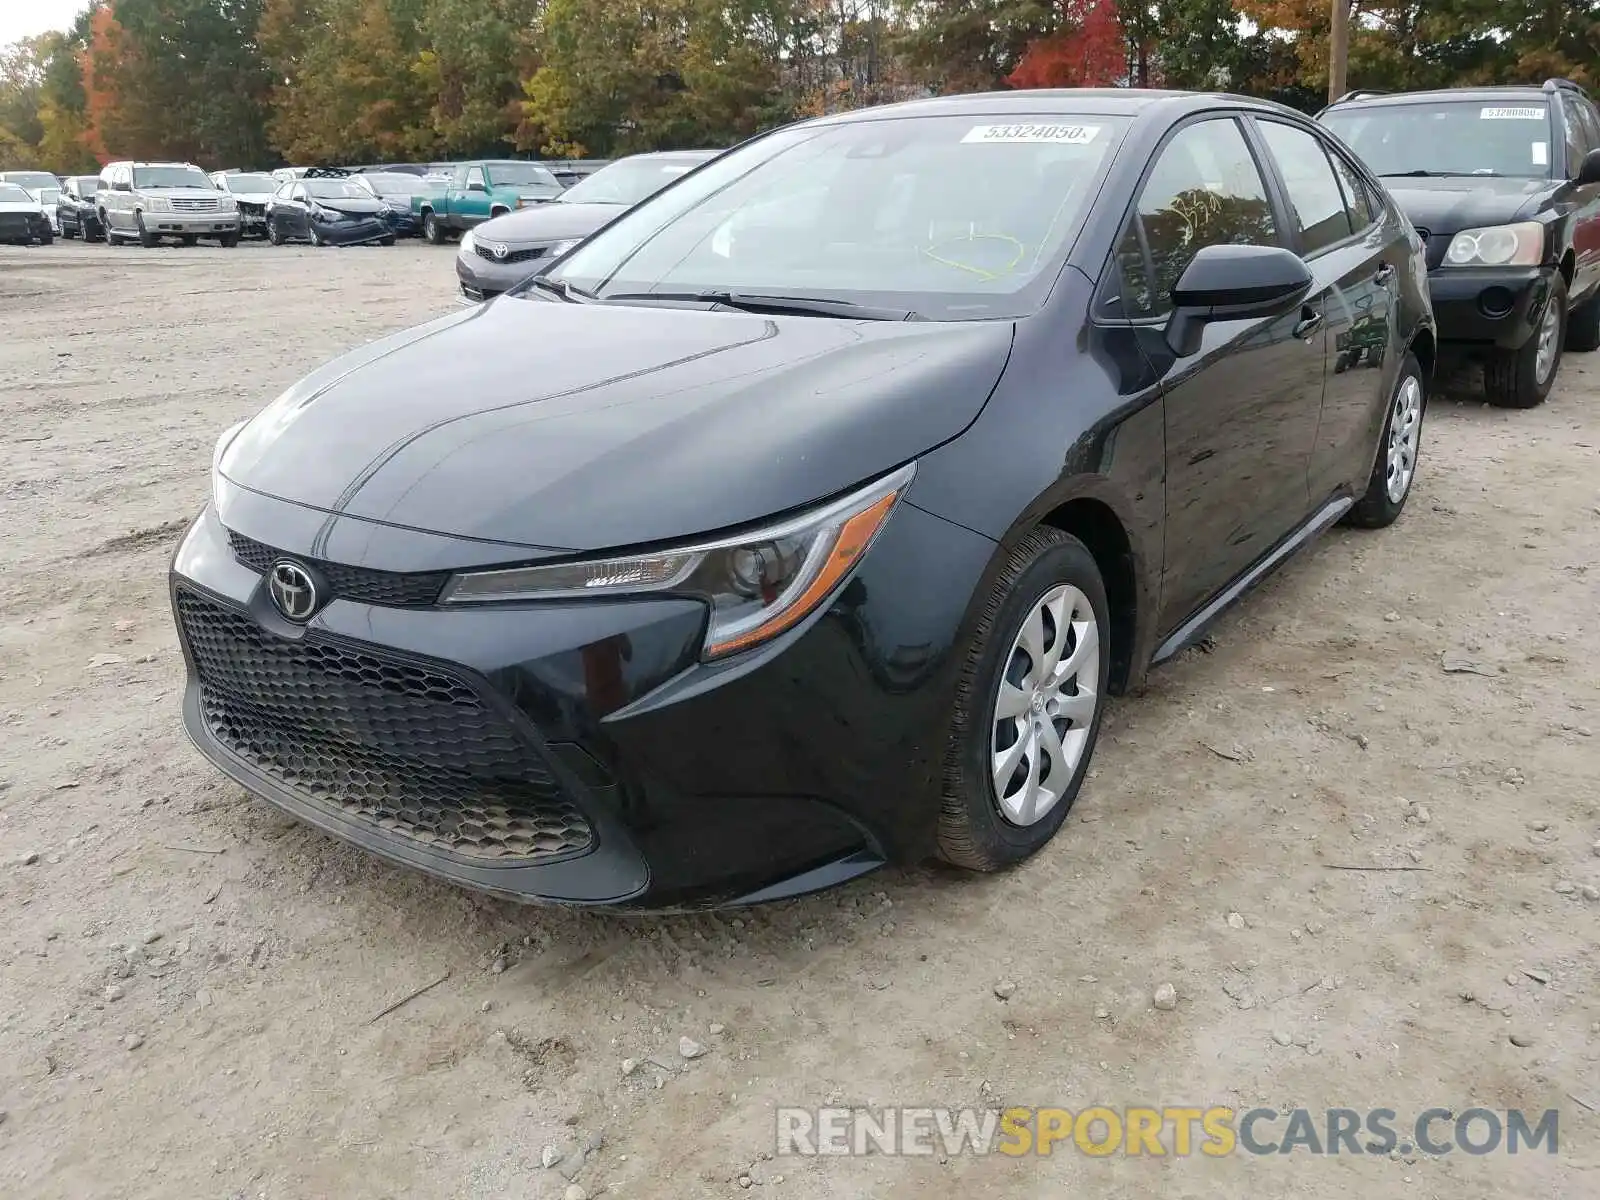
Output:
top-left (938, 528), bottom-right (1110, 870)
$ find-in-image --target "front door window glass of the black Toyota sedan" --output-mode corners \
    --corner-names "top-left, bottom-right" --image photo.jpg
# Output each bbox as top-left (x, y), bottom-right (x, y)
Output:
top-left (1102, 117), bottom-right (1280, 318)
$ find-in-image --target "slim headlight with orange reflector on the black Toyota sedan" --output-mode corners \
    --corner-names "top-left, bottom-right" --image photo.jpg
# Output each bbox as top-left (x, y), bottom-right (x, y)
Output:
top-left (440, 464), bottom-right (915, 659)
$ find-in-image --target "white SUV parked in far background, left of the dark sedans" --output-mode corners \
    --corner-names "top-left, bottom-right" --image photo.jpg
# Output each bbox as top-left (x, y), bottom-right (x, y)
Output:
top-left (94, 163), bottom-right (238, 246)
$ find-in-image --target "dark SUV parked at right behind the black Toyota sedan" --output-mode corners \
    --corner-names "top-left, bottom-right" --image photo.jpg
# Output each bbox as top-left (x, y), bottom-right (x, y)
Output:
top-left (1320, 80), bottom-right (1600, 408)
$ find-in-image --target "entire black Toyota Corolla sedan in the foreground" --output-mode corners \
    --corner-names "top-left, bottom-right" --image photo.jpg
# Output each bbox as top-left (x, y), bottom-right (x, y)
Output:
top-left (171, 91), bottom-right (1434, 909)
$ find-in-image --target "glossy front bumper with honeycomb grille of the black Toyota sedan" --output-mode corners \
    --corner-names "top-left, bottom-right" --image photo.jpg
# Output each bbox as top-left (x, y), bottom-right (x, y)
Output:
top-left (171, 486), bottom-right (994, 910)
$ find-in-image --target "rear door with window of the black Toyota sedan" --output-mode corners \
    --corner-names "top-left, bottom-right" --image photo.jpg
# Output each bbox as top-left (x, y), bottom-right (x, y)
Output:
top-left (1254, 117), bottom-right (1411, 504)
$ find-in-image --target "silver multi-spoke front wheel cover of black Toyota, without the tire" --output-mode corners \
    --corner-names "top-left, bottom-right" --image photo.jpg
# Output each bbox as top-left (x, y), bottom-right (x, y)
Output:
top-left (989, 584), bottom-right (1101, 826)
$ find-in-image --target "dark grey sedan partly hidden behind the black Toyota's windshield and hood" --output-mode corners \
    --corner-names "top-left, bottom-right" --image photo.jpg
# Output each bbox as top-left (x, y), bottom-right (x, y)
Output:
top-left (456, 150), bottom-right (717, 301)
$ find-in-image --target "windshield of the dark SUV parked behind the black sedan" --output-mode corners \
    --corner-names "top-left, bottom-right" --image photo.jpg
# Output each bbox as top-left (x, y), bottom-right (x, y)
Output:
top-left (1322, 98), bottom-right (1550, 179)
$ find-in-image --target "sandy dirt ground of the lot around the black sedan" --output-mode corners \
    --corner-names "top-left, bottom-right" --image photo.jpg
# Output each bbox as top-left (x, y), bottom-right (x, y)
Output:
top-left (0, 243), bottom-right (1600, 1200)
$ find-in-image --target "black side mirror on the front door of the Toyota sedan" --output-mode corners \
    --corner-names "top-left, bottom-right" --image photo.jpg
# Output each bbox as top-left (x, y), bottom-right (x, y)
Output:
top-left (1166, 245), bottom-right (1312, 357)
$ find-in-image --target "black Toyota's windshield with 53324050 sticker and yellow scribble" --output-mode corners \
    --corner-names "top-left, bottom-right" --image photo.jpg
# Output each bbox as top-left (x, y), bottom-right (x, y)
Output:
top-left (550, 114), bottom-right (1126, 320)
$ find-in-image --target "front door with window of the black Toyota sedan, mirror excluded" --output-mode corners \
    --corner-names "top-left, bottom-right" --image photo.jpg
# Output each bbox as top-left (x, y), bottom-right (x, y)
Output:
top-left (1117, 117), bottom-right (1323, 634)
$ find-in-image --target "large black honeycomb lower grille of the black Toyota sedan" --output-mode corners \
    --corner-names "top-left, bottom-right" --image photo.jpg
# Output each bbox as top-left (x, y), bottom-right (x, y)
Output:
top-left (176, 589), bottom-right (594, 862)
